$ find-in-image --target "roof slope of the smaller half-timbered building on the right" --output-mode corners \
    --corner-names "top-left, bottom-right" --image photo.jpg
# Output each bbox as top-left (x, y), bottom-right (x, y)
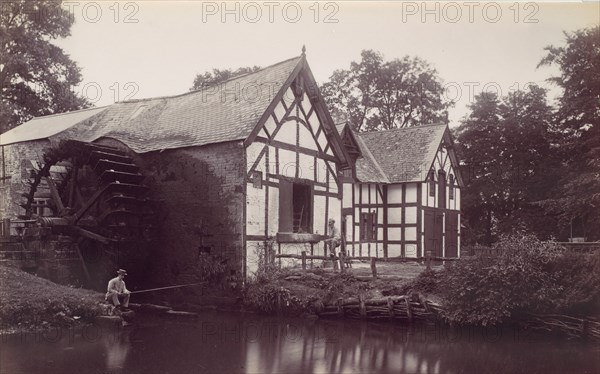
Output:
top-left (357, 124), bottom-right (447, 183)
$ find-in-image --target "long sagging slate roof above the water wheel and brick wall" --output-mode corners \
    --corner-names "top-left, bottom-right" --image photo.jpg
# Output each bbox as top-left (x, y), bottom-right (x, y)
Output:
top-left (2, 57), bottom-right (302, 153)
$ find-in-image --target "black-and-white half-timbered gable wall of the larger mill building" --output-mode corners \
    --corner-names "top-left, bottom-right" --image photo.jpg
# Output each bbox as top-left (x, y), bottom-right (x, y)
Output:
top-left (246, 83), bottom-right (341, 272)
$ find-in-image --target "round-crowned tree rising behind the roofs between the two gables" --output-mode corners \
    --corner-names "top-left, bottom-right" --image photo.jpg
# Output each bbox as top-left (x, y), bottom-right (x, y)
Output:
top-left (322, 50), bottom-right (451, 131)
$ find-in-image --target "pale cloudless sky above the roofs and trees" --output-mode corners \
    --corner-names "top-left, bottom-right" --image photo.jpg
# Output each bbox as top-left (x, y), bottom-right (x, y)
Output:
top-left (55, 0), bottom-right (600, 126)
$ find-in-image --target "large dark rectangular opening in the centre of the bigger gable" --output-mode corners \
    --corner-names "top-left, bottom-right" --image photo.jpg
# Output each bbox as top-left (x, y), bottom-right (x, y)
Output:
top-left (279, 180), bottom-right (313, 233)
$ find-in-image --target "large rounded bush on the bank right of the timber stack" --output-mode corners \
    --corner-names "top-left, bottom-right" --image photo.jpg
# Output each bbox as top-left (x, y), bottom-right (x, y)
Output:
top-left (441, 236), bottom-right (561, 326)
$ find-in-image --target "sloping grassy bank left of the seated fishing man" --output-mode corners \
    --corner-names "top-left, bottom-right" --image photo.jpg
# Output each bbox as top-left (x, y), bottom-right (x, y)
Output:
top-left (0, 266), bottom-right (102, 332)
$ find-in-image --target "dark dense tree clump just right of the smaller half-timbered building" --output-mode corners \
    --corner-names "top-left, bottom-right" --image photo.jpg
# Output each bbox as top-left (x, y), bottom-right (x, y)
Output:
top-left (456, 85), bottom-right (560, 245)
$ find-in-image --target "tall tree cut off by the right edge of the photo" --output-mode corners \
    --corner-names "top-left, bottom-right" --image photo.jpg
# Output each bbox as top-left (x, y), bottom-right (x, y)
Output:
top-left (539, 26), bottom-right (600, 240)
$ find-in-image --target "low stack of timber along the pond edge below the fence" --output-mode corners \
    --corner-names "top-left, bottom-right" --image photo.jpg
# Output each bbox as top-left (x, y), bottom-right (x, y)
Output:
top-left (317, 295), bottom-right (435, 323)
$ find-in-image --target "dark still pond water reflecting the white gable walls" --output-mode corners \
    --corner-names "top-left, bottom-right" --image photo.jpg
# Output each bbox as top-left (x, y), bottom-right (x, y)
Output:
top-left (0, 312), bottom-right (600, 374)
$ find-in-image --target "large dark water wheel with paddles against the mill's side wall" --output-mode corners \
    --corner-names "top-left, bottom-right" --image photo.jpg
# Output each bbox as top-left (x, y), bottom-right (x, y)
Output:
top-left (21, 140), bottom-right (156, 289)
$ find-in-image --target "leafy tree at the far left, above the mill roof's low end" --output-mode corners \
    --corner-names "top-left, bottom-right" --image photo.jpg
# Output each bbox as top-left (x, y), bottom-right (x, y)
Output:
top-left (0, 0), bottom-right (89, 133)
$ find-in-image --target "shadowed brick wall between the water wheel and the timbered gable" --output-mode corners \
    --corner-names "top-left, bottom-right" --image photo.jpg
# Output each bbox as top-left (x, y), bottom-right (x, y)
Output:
top-left (127, 142), bottom-right (245, 290)
